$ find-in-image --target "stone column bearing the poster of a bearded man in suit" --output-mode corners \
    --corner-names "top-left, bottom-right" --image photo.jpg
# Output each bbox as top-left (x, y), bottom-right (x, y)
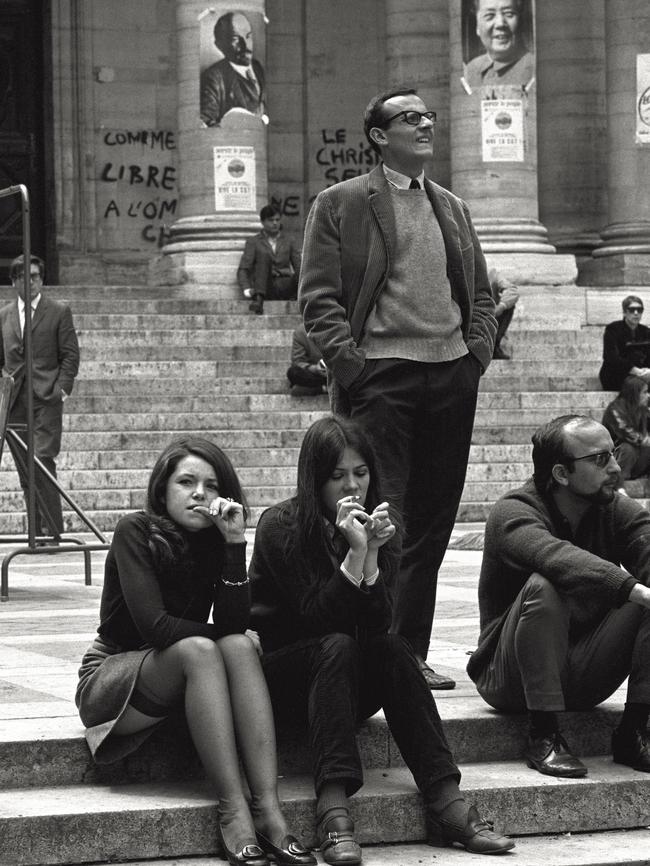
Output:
top-left (151, 0), bottom-right (267, 290)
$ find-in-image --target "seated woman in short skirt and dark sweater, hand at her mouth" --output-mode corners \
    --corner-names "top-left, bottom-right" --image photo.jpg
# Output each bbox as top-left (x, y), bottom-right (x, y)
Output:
top-left (76, 437), bottom-right (316, 866)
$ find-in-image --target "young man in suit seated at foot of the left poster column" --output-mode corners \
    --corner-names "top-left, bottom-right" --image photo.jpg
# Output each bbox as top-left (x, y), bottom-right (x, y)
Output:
top-left (237, 205), bottom-right (300, 315)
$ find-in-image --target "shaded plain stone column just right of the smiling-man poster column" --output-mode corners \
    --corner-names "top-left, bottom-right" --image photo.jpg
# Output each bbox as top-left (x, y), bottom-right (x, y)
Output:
top-left (536, 0), bottom-right (607, 255)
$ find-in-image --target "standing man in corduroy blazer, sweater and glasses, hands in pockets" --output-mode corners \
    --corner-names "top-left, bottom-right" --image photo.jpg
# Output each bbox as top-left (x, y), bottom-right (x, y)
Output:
top-left (299, 88), bottom-right (496, 689)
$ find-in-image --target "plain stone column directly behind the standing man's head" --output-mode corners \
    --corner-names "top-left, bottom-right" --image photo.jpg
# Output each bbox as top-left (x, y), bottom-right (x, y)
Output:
top-left (385, 0), bottom-right (451, 187)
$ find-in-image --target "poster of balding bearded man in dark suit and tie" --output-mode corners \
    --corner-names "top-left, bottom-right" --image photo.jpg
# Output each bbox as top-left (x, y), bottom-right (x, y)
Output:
top-left (199, 4), bottom-right (267, 126)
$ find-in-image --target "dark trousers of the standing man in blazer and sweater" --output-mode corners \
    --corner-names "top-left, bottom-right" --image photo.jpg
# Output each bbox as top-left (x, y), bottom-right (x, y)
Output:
top-left (349, 354), bottom-right (481, 658)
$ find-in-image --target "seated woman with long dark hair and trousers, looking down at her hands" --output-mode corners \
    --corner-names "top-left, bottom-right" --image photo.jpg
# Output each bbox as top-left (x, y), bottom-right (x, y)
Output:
top-left (249, 416), bottom-right (514, 864)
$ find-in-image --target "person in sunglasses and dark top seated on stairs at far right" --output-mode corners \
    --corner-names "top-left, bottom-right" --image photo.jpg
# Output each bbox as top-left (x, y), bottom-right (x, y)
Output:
top-left (598, 295), bottom-right (650, 391)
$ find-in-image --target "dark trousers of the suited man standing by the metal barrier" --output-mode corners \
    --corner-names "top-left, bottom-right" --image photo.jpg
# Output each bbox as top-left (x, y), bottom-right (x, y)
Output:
top-left (9, 387), bottom-right (63, 535)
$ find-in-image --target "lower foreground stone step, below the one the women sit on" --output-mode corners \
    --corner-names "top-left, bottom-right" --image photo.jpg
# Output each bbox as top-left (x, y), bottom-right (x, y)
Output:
top-left (0, 758), bottom-right (650, 866)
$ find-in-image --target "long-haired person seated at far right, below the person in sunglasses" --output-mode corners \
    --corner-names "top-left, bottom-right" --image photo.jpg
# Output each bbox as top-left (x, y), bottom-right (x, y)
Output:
top-left (603, 376), bottom-right (650, 493)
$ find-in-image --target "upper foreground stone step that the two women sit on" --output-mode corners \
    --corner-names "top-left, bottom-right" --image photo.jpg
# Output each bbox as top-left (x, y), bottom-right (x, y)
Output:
top-left (0, 696), bottom-right (623, 790)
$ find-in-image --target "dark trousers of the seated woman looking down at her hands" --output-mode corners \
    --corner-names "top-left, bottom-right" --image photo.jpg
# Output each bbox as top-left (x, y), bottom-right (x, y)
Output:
top-left (262, 633), bottom-right (460, 799)
